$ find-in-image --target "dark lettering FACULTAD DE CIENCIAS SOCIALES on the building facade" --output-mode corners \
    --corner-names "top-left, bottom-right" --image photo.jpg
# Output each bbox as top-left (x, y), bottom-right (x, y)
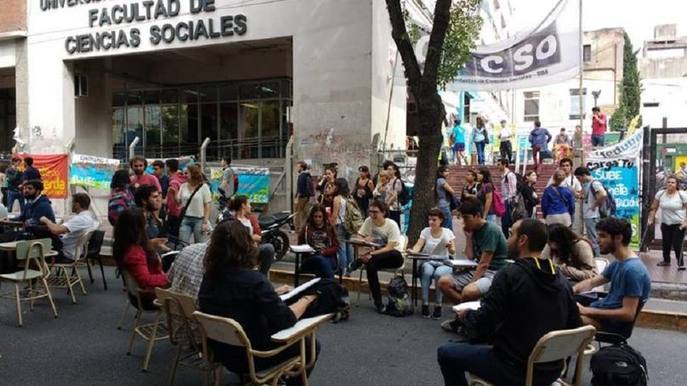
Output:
top-left (59, 0), bottom-right (248, 55)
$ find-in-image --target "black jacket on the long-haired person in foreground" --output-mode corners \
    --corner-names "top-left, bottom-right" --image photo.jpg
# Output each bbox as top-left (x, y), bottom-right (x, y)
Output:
top-left (198, 269), bottom-right (296, 352)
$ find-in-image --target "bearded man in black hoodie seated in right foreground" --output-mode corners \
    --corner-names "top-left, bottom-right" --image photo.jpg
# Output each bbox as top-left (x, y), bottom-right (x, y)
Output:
top-left (438, 219), bottom-right (582, 386)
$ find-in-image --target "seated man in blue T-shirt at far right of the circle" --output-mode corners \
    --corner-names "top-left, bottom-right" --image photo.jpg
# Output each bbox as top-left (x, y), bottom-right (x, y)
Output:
top-left (573, 217), bottom-right (651, 333)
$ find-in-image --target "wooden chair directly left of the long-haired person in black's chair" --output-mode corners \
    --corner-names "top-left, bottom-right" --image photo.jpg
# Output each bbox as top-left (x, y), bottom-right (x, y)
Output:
top-left (155, 288), bottom-right (222, 386)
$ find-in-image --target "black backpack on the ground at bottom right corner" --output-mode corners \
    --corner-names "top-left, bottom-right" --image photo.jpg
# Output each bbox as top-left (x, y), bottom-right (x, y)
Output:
top-left (589, 341), bottom-right (649, 386)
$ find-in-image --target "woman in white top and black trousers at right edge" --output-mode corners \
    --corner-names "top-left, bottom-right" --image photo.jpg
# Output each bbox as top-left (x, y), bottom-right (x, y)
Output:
top-left (647, 176), bottom-right (687, 271)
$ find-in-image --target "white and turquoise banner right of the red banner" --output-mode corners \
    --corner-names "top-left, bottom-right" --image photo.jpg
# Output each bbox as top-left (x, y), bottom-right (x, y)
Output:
top-left (69, 154), bottom-right (120, 190)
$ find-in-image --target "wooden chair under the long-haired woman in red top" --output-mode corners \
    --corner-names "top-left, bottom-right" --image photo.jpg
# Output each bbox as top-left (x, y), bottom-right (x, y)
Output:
top-left (122, 270), bottom-right (169, 371)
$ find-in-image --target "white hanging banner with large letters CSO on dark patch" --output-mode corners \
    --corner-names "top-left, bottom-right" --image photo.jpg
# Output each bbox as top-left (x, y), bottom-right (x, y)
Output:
top-left (451, 0), bottom-right (581, 91)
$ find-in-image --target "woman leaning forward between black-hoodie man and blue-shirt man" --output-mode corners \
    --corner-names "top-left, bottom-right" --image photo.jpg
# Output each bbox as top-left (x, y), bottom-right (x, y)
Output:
top-left (542, 224), bottom-right (599, 282)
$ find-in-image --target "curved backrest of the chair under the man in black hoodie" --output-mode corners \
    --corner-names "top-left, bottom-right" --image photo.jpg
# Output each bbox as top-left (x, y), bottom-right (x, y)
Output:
top-left (525, 326), bottom-right (596, 385)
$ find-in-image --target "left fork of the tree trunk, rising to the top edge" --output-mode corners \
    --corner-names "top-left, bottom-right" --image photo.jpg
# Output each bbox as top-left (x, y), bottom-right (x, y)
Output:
top-left (386, 0), bottom-right (424, 92)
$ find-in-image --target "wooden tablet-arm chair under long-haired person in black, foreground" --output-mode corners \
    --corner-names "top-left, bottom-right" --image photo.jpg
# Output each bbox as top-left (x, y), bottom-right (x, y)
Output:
top-left (193, 311), bottom-right (332, 386)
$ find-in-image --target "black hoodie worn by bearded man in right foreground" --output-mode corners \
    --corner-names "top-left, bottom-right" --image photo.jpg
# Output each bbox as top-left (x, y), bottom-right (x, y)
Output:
top-left (464, 258), bottom-right (582, 385)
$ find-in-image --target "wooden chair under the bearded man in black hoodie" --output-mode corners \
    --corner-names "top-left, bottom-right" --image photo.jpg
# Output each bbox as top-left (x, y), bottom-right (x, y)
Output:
top-left (470, 326), bottom-right (596, 386)
